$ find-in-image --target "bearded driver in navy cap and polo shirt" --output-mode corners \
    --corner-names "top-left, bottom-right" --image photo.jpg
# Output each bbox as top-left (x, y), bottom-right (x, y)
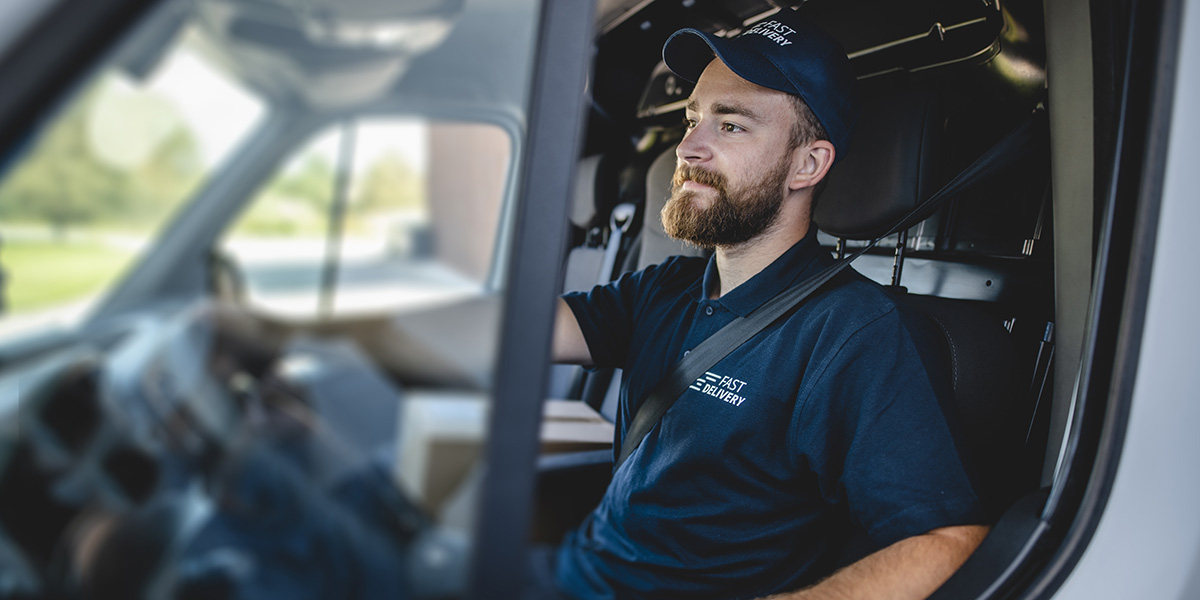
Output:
top-left (554, 10), bottom-right (986, 599)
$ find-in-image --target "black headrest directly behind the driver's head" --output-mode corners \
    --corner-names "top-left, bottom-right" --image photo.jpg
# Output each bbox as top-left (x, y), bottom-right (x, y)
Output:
top-left (812, 89), bottom-right (944, 240)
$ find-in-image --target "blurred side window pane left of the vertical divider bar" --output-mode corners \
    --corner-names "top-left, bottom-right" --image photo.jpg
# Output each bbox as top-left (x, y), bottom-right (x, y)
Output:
top-left (0, 0), bottom-right (544, 600)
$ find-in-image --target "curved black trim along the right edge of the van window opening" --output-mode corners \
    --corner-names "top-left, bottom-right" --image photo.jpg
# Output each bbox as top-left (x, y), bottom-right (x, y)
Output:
top-left (980, 0), bottom-right (1183, 599)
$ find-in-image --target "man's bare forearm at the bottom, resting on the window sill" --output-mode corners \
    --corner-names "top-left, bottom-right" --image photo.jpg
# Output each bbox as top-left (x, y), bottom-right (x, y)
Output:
top-left (768, 526), bottom-right (988, 600)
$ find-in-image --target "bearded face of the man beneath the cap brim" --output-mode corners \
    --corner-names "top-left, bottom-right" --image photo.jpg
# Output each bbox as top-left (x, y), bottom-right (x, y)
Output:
top-left (662, 60), bottom-right (797, 248)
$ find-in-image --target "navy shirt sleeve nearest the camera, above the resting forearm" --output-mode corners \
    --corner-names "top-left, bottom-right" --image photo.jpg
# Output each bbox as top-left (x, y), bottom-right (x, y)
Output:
top-left (797, 302), bottom-right (984, 547)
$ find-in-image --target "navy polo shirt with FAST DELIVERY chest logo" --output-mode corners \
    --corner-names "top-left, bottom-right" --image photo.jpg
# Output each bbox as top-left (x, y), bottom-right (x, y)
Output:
top-left (557, 226), bottom-right (983, 599)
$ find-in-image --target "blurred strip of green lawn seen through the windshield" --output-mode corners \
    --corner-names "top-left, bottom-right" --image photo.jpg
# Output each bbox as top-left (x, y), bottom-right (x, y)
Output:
top-left (0, 239), bottom-right (134, 313)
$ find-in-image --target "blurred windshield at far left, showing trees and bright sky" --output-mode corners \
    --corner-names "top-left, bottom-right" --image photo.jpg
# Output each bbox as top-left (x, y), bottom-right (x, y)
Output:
top-left (0, 29), bottom-right (265, 343)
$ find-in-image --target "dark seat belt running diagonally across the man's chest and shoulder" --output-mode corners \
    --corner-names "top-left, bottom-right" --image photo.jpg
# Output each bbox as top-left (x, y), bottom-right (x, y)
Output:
top-left (613, 110), bottom-right (1046, 470)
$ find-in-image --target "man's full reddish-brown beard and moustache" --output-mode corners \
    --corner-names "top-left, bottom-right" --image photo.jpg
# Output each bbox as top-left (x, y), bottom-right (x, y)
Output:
top-left (662, 160), bottom-right (788, 250)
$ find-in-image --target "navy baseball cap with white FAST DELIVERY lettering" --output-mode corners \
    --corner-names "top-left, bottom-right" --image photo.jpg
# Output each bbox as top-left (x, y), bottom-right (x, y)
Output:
top-left (662, 8), bottom-right (858, 160)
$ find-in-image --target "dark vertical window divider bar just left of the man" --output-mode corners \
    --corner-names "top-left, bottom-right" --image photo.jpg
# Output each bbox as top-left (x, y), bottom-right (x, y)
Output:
top-left (470, 1), bottom-right (594, 598)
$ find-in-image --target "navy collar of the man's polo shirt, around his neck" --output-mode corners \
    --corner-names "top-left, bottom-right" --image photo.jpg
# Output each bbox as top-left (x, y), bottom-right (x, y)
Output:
top-left (692, 227), bottom-right (829, 317)
